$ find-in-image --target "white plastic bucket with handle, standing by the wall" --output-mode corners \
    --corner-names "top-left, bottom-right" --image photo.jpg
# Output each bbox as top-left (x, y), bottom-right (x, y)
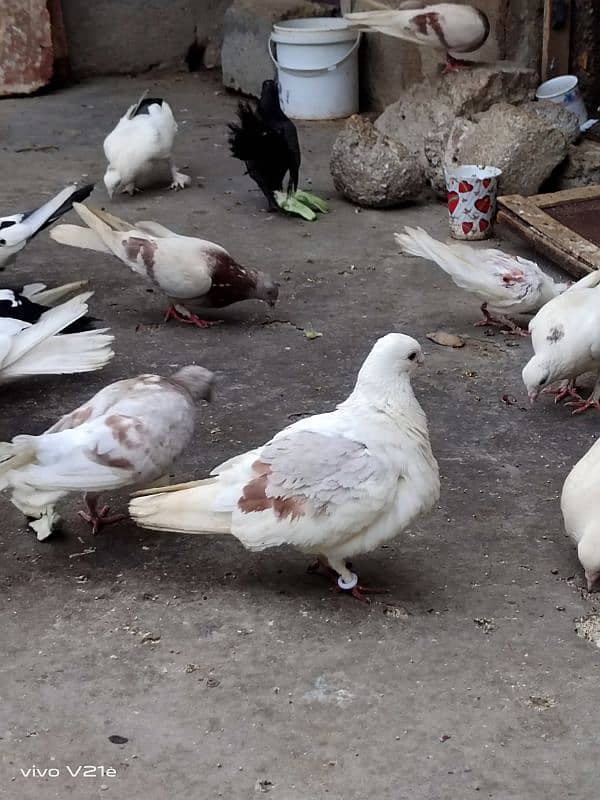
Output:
top-left (269, 17), bottom-right (360, 119)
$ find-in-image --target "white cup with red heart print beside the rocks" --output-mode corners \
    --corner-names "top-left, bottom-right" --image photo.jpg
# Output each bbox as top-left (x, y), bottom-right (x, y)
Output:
top-left (446, 164), bottom-right (502, 240)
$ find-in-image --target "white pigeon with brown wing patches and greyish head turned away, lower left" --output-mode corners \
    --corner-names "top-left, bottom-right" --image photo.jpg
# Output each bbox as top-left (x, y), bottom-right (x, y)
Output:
top-left (0, 366), bottom-right (213, 540)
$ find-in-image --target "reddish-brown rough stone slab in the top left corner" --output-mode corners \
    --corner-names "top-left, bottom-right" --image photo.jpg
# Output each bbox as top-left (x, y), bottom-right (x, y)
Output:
top-left (0, 0), bottom-right (53, 95)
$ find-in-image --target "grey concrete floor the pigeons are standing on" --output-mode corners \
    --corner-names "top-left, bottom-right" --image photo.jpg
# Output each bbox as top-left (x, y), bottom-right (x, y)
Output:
top-left (0, 70), bottom-right (600, 800)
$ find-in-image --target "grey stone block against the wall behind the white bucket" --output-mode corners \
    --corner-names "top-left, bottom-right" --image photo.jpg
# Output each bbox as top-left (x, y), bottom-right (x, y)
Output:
top-left (221, 0), bottom-right (331, 97)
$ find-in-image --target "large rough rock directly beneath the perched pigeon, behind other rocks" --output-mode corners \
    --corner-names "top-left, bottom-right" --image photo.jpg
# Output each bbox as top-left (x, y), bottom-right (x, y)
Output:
top-left (375, 62), bottom-right (537, 166)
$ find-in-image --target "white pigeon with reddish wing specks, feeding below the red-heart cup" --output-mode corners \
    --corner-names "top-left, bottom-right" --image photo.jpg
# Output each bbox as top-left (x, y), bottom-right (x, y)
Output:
top-left (394, 227), bottom-right (571, 335)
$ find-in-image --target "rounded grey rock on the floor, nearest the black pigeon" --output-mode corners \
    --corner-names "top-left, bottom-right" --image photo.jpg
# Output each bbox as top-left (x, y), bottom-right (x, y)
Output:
top-left (330, 114), bottom-right (425, 208)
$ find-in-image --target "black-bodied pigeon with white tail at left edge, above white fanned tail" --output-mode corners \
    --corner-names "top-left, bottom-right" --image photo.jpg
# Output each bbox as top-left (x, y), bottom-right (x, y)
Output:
top-left (0, 281), bottom-right (94, 333)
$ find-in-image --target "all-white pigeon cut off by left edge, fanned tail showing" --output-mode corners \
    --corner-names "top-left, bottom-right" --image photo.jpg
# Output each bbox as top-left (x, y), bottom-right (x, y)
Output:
top-left (0, 292), bottom-right (114, 383)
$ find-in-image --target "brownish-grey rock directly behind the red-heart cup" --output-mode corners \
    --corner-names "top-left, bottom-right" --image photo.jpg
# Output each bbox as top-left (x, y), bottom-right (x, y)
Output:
top-left (425, 103), bottom-right (569, 195)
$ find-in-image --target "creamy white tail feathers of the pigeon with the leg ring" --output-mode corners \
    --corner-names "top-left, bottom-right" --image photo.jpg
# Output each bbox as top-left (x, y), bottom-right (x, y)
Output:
top-left (129, 478), bottom-right (231, 534)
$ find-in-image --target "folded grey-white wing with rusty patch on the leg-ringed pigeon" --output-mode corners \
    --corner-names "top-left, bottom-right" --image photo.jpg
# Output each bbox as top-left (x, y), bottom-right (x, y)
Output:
top-left (227, 431), bottom-right (400, 552)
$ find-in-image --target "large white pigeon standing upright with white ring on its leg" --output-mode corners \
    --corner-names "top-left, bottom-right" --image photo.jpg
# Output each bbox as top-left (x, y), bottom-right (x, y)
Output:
top-left (130, 333), bottom-right (440, 600)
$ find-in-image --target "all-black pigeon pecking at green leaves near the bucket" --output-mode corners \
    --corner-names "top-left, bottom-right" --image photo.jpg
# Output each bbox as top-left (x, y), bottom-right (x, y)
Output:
top-left (229, 80), bottom-right (301, 211)
